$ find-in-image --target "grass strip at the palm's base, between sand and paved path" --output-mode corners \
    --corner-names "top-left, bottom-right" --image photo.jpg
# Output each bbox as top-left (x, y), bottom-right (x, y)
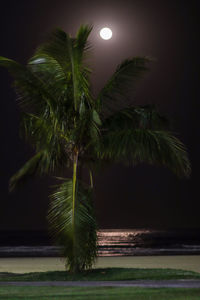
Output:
top-left (0, 268), bottom-right (200, 281)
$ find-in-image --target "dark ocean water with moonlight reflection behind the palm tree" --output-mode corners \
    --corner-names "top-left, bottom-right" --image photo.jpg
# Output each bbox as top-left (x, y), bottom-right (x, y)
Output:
top-left (0, 229), bottom-right (200, 257)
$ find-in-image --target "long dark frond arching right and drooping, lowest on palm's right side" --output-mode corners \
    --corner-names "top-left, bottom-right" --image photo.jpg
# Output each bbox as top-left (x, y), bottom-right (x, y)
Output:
top-left (99, 128), bottom-right (191, 177)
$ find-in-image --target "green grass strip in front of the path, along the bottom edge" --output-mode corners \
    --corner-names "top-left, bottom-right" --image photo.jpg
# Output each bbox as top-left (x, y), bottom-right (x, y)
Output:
top-left (0, 286), bottom-right (200, 300)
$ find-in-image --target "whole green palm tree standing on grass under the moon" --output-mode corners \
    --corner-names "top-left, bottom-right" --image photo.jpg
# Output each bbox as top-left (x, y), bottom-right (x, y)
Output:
top-left (0, 25), bottom-right (190, 272)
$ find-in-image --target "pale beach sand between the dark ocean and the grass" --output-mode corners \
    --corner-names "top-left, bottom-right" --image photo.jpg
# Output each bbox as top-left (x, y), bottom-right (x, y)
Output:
top-left (0, 255), bottom-right (200, 273)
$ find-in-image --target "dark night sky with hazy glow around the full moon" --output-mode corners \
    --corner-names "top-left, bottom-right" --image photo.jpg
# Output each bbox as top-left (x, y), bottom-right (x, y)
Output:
top-left (0, 0), bottom-right (200, 230)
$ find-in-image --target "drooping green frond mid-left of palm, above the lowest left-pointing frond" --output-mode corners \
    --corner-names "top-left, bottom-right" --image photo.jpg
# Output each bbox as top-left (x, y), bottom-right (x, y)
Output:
top-left (21, 114), bottom-right (70, 173)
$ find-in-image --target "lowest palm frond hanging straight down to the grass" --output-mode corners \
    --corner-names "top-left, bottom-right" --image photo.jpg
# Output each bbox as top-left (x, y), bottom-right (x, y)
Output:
top-left (48, 179), bottom-right (97, 271)
